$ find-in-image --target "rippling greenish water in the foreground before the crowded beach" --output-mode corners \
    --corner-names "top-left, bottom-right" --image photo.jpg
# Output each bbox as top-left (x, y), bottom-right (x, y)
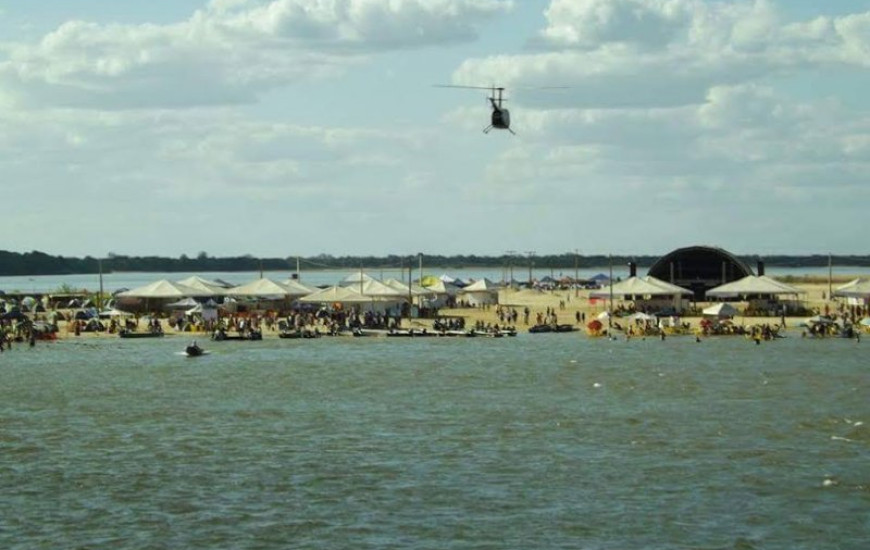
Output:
top-left (0, 334), bottom-right (870, 549)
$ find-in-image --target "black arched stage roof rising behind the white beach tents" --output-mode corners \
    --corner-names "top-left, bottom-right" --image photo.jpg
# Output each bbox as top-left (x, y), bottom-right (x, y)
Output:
top-left (648, 246), bottom-right (754, 300)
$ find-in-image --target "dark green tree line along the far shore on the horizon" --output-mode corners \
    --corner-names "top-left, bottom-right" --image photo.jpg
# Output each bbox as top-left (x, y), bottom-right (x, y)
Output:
top-left (0, 250), bottom-right (870, 276)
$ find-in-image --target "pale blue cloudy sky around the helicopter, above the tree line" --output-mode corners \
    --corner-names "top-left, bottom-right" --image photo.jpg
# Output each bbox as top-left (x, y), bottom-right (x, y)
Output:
top-left (0, 0), bottom-right (870, 257)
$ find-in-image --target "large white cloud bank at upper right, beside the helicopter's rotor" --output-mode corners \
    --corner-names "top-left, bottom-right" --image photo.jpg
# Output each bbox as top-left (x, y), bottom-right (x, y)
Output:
top-left (453, 0), bottom-right (870, 108)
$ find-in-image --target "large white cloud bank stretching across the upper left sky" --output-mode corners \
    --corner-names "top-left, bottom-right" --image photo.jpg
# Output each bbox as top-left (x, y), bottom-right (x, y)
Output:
top-left (0, 0), bottom-right (511, 109)
